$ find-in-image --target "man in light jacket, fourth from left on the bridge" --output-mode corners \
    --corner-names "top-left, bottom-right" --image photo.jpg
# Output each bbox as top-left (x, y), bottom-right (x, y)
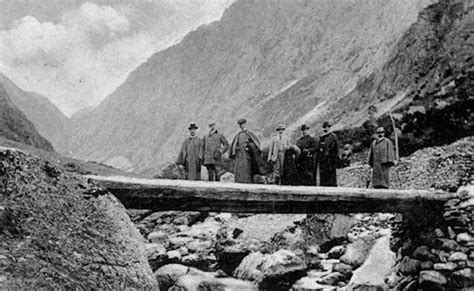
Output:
top-left (267, 124), bottom-right (290, 184)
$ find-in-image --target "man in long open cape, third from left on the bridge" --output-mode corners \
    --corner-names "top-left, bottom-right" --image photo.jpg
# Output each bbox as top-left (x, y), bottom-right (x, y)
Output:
top-left (229, 119), bottom-right (261, 183)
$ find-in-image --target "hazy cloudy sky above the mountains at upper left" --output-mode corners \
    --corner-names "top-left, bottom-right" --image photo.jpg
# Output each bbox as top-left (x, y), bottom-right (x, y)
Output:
top-left (0, 0), bottom-right (234, 115)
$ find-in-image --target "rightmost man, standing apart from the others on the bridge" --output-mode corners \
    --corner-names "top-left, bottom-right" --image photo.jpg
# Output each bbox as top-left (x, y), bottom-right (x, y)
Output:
top-left (368, 127), bottom-right (397, 189)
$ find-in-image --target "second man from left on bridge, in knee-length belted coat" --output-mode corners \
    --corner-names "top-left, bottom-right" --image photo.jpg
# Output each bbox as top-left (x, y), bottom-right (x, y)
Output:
top-left (202, 122), bottom-right (229, 181)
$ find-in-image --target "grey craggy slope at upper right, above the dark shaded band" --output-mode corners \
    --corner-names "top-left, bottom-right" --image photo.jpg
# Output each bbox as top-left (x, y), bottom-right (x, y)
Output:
top-left (328, 0), bottom-right (474, 127)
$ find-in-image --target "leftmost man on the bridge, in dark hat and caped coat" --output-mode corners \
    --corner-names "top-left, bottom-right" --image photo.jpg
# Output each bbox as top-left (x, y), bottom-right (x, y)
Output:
top-left (176, 123), bottom-right (203, 180)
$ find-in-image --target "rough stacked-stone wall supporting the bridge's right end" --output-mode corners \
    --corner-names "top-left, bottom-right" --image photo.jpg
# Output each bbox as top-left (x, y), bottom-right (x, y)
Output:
top-left (389, 185), bottom-right (474, 290)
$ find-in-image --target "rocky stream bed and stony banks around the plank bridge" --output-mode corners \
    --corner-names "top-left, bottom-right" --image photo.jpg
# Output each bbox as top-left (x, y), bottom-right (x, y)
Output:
top-left (0, 138), bottom-right (474, 290)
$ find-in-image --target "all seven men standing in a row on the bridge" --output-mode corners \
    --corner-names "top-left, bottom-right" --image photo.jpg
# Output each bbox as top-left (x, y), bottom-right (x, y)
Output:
top-left (177, 119), bottom-right (396, 188)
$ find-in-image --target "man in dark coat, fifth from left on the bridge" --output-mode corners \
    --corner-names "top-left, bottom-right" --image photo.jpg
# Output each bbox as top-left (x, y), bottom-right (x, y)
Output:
top-left (296, 124), bottom-right (318, 186)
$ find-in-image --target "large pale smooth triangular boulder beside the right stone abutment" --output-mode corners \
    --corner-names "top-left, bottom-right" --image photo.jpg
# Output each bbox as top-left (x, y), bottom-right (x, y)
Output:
top-left (348, 236), bottom-right (395, 290)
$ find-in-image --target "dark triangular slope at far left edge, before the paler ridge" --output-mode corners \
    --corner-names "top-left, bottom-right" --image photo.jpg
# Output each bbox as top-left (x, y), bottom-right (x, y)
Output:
top-left (0, 79), bottom-right (53, 151)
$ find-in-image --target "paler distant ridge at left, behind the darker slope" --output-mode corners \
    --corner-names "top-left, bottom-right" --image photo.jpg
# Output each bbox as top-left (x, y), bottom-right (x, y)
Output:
top-left (0, 74), bottom-right (70, 152)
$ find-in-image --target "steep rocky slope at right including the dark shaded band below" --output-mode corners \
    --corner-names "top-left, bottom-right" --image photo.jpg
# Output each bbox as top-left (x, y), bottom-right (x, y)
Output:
top-left (334, 1), bottom-right (474, 159)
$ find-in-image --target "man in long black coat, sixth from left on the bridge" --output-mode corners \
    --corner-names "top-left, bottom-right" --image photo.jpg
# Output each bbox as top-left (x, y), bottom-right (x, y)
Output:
top-left (317, 121), bottom-right (339, 187)
